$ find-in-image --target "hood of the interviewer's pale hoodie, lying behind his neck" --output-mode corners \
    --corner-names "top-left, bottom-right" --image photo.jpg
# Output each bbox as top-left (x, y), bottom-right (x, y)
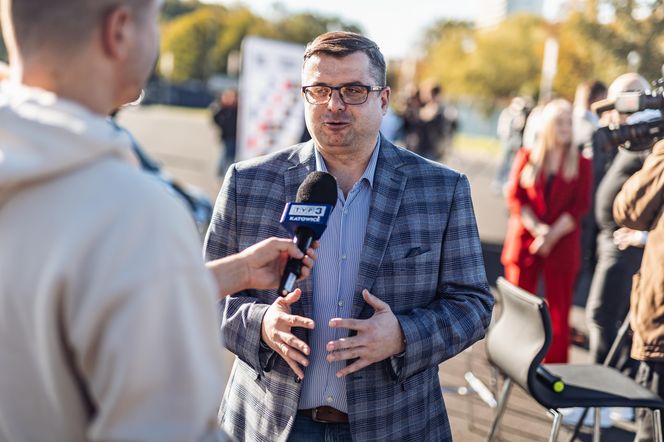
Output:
top-left (0, 83), bottom-right (135, 204)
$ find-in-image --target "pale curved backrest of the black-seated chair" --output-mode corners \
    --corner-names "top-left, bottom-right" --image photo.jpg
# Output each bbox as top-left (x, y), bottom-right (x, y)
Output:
top-left (486, 277), bottom-right (551, 391)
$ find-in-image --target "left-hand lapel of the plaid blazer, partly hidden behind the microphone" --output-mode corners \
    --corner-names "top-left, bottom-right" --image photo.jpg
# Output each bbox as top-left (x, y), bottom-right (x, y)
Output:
top-left (284, 141), bottom-right (316, 318)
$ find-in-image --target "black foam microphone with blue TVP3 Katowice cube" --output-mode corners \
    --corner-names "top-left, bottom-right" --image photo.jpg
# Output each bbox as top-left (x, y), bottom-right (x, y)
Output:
top-left (279, 172), bottom-right (337, 296)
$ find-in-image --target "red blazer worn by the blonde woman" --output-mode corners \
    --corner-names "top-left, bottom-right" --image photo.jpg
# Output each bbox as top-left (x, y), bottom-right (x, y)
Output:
top-left (501, 148), bottom-right (592, 272)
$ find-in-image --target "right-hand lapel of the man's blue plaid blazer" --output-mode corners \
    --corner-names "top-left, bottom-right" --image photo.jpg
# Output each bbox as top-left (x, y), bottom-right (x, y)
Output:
top-left (352, 136), bottom-right (408, 318)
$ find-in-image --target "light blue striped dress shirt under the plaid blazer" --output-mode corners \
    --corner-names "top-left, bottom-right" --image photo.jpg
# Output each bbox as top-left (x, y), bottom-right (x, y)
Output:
top-left (299, 137), bottom-right (380, 412)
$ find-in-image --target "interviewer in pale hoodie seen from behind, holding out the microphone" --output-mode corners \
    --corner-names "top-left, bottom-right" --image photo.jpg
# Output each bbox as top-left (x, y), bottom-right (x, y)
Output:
top-left (0, 0), bottom-right (314, 442)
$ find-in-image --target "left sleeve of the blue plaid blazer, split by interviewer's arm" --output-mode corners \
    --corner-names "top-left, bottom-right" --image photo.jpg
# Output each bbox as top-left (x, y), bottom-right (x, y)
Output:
top-left (204, 165), bottom-right (269, 374)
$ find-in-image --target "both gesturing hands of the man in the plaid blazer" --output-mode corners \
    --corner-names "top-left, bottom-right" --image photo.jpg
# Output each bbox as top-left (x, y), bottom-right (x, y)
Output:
top-left (261, 289), bottom-right (405, 379)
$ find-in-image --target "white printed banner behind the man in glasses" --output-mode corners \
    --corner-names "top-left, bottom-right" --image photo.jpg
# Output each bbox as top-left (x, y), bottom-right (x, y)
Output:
top-left (236, 37), bottom-right (304, 161)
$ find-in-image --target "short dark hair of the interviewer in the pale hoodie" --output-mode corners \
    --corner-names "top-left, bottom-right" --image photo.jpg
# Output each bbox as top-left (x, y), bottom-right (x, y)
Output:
top-left (0, 0), bottom-right (152, 54)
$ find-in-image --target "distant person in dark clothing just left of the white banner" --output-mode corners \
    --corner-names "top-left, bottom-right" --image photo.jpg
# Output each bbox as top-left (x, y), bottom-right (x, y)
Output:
top-left (212, 89), bottom-right (237, 178)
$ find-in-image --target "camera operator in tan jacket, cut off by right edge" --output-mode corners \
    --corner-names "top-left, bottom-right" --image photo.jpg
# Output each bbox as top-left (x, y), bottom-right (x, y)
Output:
top-left (613, 141), bottom-right (664, 441)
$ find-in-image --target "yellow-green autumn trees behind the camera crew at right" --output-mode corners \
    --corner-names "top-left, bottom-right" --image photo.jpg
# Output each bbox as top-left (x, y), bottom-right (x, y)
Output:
top-left (418, 0), bottom-right (664, 109)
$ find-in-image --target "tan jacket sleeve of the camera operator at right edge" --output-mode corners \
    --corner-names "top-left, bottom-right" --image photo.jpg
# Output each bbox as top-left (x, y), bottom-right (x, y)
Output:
top-left (613, 141), bottom-right (664, 230)
